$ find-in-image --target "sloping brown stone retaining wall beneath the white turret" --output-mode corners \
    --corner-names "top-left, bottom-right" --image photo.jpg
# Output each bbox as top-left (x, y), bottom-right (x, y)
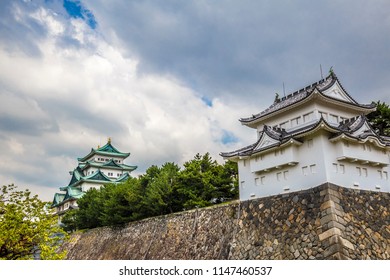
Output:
top-left (65, 184), bottom-right (390, 260)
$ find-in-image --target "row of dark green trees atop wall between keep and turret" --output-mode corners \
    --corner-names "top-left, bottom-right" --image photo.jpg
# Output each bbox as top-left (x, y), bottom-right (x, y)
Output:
top-left (62, 153), bottom-right (238, 230)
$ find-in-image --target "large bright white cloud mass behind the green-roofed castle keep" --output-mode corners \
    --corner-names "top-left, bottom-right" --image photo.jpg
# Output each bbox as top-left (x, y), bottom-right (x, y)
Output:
top-left (0, 2), bottom-right (245, 198)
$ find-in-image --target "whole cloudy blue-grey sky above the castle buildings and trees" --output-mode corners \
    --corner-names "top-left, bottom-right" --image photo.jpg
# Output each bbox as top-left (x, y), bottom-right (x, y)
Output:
top-left (0, 0), bottom-right (390, 201)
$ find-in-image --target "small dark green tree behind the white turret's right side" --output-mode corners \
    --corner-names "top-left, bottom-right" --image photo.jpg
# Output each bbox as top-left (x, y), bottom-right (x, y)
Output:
top-left (367, 101), bottom-right (390, 136)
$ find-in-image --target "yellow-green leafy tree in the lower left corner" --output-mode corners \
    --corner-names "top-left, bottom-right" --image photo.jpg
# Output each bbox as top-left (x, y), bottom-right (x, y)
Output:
top-left (0, 185), bottom-right (66, 260)
